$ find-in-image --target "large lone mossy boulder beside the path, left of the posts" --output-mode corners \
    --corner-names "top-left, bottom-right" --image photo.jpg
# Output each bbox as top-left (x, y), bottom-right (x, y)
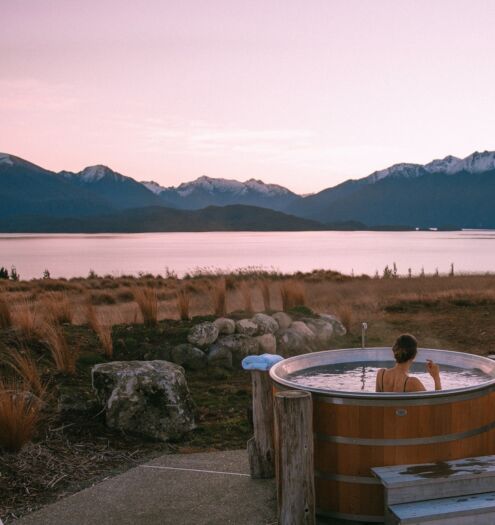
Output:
top-left (92, 361), bottom-right (195, 441)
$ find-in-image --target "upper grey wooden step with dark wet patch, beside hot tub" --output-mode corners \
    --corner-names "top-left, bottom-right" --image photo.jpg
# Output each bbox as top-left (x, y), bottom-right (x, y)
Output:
top-left (371, 456), bottom-right (495, 504)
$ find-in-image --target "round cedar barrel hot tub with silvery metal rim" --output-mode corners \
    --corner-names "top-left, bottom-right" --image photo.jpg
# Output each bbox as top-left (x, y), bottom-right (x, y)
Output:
top-left (270, 348), bottom-right (495, 523)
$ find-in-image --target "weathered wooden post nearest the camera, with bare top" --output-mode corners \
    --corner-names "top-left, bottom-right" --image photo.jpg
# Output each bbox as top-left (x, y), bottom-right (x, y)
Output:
top-left (275, 390), bottom-right (316, 525)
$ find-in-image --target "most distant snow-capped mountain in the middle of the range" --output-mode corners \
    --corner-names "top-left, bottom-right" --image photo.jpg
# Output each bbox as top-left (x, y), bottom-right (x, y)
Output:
top-left (142, 175), bottom-right (301, 210)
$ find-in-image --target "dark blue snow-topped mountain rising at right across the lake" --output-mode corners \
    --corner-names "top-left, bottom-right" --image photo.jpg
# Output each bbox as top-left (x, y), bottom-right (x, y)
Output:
top-left (286, 151), bottom-right (495, 228)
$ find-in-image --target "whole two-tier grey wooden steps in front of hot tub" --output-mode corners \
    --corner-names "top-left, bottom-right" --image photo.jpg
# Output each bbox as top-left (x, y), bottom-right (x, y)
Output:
top-left (371, 456), bottom-right (495, 525)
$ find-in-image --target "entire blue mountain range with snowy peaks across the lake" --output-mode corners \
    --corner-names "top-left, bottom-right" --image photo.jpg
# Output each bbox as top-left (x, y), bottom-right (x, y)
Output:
top-left (0, 147), bottom-right (495, 232)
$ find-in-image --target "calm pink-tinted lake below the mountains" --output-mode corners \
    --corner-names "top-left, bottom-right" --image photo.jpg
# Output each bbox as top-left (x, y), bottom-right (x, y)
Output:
top-left (0, 230), bottom-right (495, 279)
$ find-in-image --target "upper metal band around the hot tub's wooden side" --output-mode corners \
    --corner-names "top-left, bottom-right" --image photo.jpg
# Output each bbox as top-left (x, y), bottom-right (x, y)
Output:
top-left (315, 421), bottom-right (495, 447)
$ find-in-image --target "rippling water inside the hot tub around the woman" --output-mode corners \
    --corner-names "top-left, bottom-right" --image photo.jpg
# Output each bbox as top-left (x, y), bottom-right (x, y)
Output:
top-left (287, 361), bottom-right (493, 392)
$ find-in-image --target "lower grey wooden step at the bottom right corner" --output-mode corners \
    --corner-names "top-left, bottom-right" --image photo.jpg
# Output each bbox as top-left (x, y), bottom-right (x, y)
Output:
top-left (388, 492), bottom-right (495, 525)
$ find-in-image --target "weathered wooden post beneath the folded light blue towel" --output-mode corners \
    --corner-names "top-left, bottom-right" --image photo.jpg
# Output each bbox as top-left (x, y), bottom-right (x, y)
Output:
top-left (247, 370), bottom-right (275, 479)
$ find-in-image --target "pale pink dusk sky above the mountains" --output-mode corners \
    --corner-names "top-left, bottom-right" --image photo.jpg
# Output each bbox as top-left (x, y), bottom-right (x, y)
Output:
top-left (0, 0), bottom-right (495, 193)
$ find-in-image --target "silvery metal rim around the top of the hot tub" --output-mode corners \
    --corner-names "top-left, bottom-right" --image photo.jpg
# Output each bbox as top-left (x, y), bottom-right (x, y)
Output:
top-left (269, 346), bottom-right (495, 403)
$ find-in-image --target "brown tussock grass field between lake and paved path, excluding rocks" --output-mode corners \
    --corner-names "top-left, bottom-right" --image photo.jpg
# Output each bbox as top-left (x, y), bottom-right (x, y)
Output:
top-left (0, 271), bottom-right (495, 522)
